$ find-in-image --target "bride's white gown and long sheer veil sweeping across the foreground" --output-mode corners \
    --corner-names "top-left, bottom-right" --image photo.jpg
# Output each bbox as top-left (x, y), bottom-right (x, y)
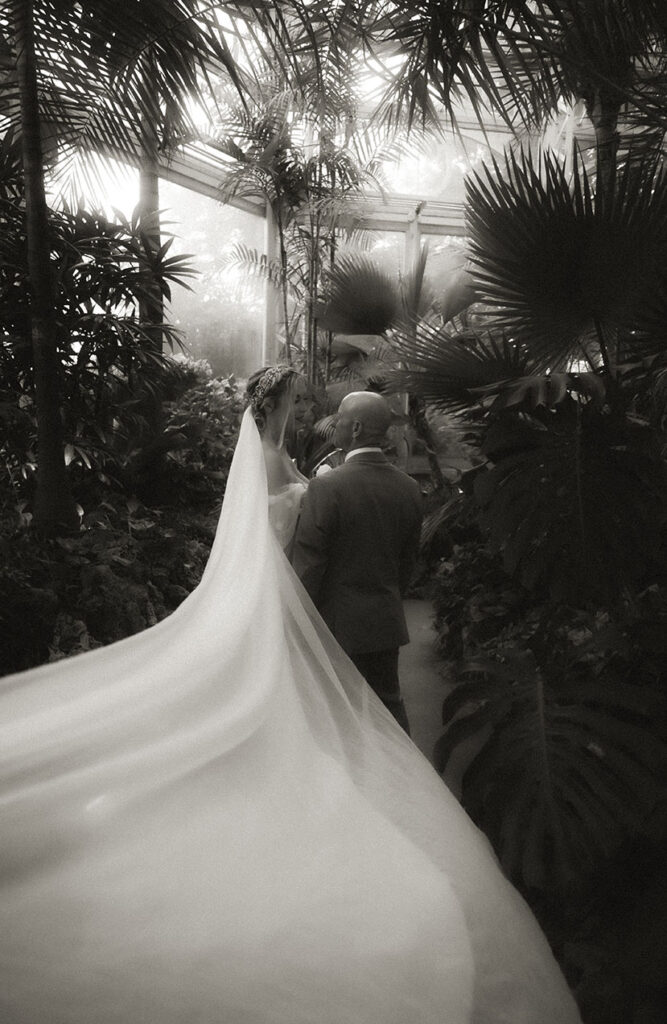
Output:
top-left (0, 414), bottom-right (579, 1024)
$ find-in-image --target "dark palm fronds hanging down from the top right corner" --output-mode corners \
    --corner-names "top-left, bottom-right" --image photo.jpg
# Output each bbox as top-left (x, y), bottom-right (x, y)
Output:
top-left (371, 0), bottom-right (667, 146)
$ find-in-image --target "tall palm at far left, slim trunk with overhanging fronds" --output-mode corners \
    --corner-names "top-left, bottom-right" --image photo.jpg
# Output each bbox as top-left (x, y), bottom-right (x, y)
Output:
top-left (0, 0), bottom-right (242, 535)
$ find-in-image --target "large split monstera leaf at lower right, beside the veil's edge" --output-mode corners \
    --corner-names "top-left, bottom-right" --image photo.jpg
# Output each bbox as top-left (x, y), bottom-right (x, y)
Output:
top-left (435, 648), bottom-right (667, 889)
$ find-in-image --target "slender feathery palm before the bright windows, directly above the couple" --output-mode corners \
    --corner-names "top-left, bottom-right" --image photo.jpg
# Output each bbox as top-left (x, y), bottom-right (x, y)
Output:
top-left (216, 92), bottom-right (402, 382)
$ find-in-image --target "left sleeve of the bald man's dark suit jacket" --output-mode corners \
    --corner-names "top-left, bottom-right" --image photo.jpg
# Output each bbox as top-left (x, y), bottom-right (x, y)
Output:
top-left (292, 477), bottom-right (335, 605)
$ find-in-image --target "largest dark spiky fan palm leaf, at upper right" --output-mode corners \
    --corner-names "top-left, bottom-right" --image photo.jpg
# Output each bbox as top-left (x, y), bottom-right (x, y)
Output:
top-left (466, 152), bottom-right (667, 372)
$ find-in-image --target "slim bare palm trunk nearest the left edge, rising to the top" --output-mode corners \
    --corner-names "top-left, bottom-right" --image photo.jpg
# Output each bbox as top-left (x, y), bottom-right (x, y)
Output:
top-left (14, 0), bottom-right (79, 537)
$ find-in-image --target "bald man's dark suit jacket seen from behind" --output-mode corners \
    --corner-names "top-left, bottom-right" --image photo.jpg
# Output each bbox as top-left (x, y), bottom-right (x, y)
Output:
top-left (292, 452), bottom-right (422, 654)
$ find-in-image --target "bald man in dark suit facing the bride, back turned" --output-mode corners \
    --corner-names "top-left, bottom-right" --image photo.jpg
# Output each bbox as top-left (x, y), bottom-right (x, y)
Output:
top-left (292, 391), bottom-right (422, 734)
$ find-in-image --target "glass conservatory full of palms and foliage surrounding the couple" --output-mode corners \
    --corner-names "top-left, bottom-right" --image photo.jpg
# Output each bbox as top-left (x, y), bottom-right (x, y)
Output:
top-left (0, 8), bottom-right (667, 1024)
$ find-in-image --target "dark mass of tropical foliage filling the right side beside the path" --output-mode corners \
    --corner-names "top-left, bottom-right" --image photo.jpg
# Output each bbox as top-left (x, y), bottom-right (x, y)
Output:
top-left (368, 12), bottom-right (667, 1022)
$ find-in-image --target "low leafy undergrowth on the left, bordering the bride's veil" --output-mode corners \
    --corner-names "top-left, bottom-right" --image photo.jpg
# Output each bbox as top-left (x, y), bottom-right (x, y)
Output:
top-left (0, 362), bottom-right (243, 674)
